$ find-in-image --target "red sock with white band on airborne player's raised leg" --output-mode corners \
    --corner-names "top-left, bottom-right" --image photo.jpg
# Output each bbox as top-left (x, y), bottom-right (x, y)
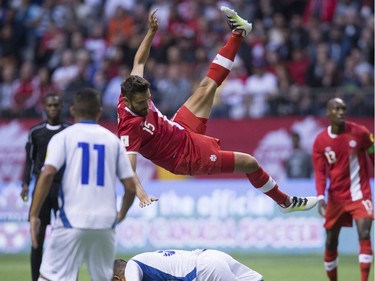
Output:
top-left (207, 33), bottom-right (243, 86)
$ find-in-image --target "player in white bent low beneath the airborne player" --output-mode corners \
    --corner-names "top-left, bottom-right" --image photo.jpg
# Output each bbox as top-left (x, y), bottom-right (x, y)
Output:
top-left (112, 249), bottom-right (263, 281)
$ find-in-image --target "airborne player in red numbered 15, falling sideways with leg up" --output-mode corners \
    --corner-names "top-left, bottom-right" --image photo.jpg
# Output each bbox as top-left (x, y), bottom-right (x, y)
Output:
top-left (117, 7), bottom-right (317, 213)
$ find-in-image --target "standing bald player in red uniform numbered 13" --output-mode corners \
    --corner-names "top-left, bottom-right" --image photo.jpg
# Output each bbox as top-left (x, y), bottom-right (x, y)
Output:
top-left (313, 98), bottom-right (374, 281)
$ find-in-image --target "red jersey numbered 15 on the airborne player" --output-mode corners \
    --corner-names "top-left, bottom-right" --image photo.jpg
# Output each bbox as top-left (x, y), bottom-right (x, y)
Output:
top-left (117, 96), bottom-right (187, 171)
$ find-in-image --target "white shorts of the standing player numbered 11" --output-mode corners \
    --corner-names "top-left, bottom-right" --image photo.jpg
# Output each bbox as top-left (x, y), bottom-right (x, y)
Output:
top-left (39, 227), bottom-right (116, 281)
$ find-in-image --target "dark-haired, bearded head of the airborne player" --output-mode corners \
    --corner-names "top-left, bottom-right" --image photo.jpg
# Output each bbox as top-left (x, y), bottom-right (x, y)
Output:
top-left (121, 75), bottom-right (151, 116)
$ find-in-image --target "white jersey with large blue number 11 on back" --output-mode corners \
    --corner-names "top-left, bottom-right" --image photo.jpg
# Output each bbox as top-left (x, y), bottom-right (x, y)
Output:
top-left (44, 121), bottom-right (134, 229)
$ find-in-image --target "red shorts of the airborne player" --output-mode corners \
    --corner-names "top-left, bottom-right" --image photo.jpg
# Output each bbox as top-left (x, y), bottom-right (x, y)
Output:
top-left (171, 105), bottom-right (234, 176)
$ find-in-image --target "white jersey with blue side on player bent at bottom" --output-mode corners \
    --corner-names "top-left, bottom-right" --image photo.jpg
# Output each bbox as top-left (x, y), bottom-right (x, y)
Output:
top-left (125, 250), bottom-right (204, 281)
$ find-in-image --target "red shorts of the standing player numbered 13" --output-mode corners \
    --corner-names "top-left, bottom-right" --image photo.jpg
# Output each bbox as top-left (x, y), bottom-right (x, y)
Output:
top-left (324, 199), bottom-right (374, 229)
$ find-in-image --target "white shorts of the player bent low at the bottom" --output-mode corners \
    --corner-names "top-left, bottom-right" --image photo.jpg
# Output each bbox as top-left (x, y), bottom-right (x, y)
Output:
top-left (197, 250), bottom-right (263, 281)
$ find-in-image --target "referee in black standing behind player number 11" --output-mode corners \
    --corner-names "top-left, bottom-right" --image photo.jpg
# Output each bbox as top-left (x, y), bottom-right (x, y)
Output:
top-left (21, 93), bottom-right (69, 281)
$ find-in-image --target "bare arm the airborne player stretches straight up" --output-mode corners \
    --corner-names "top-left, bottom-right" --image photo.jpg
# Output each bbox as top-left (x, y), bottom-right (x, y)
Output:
top-left (130, 9), bottom-right (159, 77)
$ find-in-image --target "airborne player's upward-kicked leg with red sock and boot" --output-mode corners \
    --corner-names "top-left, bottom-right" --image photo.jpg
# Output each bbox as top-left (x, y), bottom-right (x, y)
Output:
top-left (184, 6), bottom-right (252, 119)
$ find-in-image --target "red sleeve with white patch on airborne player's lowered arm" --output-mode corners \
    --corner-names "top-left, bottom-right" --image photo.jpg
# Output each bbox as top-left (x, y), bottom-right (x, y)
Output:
top-left (117, 118), bottom-right (142, 152)
